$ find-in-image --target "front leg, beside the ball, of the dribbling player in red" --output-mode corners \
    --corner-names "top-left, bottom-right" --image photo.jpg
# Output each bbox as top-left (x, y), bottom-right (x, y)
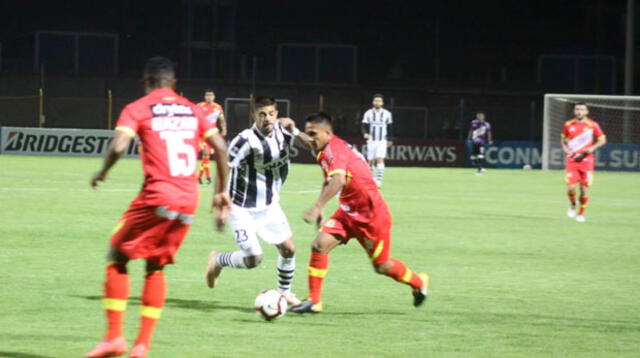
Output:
top-left (291, 231), bottom-right (344, 313)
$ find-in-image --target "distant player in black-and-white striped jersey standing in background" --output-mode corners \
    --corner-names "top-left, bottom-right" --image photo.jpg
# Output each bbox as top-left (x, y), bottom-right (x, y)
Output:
top-left (362, 93), bottom-right (393, 187)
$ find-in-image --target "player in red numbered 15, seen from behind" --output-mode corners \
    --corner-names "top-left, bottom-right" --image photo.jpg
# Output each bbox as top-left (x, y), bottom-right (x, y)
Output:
top-left (85, 57), bottom-right (230, 358)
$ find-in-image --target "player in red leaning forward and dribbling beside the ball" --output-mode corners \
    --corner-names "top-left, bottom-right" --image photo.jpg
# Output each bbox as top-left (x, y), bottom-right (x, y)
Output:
top-left (291, 113), bottom-right (429, 313)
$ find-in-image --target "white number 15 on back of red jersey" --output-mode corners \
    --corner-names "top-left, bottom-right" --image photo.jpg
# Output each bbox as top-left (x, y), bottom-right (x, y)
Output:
top-left (160, 131), bottom-right (196, 177)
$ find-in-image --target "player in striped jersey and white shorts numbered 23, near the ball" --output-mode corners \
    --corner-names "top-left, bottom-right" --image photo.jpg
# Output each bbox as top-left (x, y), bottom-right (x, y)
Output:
top-left (201, 97), bottom-right (309, 305)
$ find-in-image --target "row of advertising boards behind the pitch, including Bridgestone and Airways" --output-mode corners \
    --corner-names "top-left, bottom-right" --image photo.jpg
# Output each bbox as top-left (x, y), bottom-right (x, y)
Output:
top-left (0, 127), bottom-right (640, 171)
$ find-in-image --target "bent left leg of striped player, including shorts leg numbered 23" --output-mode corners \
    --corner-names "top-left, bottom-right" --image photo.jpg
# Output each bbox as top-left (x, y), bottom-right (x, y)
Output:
top-left (205, 206), bottom-right (262, 288)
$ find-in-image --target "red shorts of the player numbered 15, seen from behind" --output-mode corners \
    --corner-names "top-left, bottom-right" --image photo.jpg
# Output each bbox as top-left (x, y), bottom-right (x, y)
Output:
top-left (111, 199), bottom-right (195, 266)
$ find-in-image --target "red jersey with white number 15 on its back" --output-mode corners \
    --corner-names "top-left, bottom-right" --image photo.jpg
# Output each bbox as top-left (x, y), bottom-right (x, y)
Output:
top-left (116, 88), bottom-right (217, 207)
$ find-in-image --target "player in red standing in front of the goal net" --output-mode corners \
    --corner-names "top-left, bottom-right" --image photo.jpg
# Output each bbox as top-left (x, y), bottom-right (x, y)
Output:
top-left (560, 103), bottom-right (607, 222)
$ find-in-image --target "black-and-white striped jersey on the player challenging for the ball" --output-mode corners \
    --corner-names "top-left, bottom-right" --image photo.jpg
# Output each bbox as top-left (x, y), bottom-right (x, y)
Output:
top-left (229, 122), bottom-right (294, 209)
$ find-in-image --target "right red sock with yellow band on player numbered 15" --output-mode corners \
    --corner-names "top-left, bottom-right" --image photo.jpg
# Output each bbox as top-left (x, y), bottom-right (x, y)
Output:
top-left (135, 271), bottom-right (167, 347)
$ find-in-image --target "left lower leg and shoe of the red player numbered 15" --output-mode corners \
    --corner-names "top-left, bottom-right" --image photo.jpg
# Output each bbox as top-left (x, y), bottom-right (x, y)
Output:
top-left (85, 247), bottom-right (129, 358)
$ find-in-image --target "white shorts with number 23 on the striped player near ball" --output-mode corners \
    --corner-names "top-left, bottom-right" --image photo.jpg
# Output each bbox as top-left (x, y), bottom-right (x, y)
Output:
top-left (229, 203), bottom-right (292, 256)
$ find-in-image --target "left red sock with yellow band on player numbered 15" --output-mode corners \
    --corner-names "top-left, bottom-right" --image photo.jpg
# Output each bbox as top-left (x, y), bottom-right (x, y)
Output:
top-left (103, 262), bottom-right (129, 340)
